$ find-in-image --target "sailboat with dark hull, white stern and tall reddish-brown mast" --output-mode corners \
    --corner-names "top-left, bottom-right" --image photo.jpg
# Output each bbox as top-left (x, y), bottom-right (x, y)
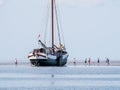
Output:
top-left (28, 0), bottom-right (69, 66)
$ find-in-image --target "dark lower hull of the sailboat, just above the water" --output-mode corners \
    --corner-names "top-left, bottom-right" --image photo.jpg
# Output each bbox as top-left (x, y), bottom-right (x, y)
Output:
top-left (30, 59), bottom-right (67, 66)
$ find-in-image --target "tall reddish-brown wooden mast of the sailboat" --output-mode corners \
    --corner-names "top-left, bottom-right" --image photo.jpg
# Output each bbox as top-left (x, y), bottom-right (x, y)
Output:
top-left (51, 0), bottom-right (54, 52)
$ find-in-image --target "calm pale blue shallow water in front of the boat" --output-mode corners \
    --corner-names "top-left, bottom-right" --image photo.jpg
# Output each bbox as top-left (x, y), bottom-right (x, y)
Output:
top-left (0, 65), bottom-right (120, 90)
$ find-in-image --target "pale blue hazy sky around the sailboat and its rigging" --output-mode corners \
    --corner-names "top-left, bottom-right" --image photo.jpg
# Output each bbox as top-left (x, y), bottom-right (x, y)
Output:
top-left (0, 0), bottom-right (120, 62)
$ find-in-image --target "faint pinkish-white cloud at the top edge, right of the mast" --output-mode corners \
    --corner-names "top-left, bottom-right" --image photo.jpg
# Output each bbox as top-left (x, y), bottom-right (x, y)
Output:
top-left (58, 0), bottom-right (108, 7)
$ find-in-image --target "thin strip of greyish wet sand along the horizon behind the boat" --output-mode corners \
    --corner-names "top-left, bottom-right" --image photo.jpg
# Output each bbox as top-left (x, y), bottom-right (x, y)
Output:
top-left (0, 60), bottom-right (120, 66)
